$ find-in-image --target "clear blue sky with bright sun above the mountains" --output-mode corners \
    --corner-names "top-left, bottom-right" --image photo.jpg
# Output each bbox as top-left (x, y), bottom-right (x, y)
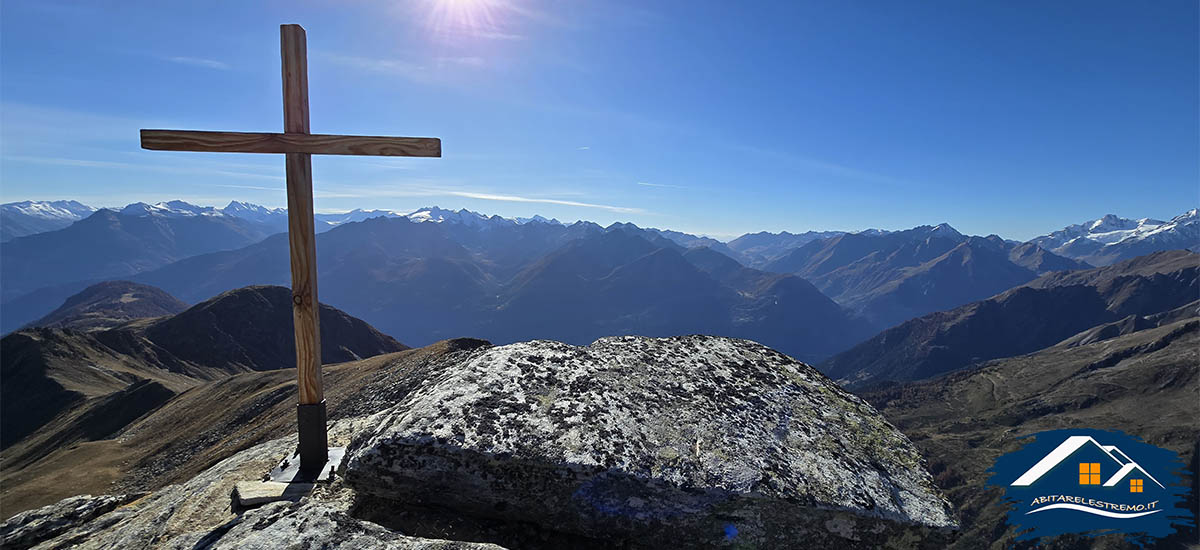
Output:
top-left (0, 0), bottom-right (1200, 239)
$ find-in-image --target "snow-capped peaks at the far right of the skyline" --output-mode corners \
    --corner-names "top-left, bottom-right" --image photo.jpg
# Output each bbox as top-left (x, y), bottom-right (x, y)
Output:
top-left (1030, 209), bottom-right (1200, 265)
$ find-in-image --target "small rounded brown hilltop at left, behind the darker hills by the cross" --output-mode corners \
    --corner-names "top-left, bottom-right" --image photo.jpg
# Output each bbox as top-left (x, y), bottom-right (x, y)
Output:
top-left (29, 281), bottom-right (187, 330)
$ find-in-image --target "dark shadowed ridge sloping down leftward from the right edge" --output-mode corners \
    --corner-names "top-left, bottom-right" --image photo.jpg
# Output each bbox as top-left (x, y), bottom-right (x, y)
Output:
top-left (821, 251), bottom-right (1200, 387)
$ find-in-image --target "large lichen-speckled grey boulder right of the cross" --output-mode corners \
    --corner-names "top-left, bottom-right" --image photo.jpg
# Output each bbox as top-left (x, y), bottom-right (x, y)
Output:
top-left (343, 336), bottom-right (955, 548)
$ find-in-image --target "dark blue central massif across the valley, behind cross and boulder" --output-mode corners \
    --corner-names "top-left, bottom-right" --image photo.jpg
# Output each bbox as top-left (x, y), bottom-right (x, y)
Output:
top-left (124, 217), bottom-right (874, 360)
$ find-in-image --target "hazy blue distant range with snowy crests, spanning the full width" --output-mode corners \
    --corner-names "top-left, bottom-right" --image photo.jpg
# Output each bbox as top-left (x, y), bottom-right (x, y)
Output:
top-left (0, 201), bottom-right (1198, 360)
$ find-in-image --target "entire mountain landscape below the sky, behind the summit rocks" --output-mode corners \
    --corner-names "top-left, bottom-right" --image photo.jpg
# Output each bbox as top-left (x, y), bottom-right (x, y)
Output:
top-left (0, 195), bottom-right (1200, 548)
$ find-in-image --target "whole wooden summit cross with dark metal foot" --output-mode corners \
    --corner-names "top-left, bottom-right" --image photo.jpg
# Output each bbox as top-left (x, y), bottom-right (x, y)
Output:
top-left (142, 25), bottom-right (442, 479)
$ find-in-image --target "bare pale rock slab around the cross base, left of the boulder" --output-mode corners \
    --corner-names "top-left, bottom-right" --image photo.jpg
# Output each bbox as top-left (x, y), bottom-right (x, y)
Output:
top-left (11, 422), bottom-right (503, 550)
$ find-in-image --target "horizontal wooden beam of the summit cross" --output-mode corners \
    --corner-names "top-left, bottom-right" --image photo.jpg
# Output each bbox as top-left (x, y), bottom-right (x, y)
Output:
top-left (142, 130), bottom-right (442, 156)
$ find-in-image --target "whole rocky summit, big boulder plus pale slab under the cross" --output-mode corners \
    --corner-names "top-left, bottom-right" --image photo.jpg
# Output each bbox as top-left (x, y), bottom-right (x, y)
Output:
top-left (0, 336), bottom-right (956, 549)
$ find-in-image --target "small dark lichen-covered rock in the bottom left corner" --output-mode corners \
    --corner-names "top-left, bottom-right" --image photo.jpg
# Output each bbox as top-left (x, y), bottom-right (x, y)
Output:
top-left (0, 494), bottom-right (142, 550)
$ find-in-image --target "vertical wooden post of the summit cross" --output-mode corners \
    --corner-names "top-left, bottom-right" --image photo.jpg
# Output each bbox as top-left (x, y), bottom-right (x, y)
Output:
top-left (280, 25), bottom-right (329, 473)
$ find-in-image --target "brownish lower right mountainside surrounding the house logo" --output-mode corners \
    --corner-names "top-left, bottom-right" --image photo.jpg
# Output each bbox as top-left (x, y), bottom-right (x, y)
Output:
top-left (863, 317), bottom-right (1200, 550)
